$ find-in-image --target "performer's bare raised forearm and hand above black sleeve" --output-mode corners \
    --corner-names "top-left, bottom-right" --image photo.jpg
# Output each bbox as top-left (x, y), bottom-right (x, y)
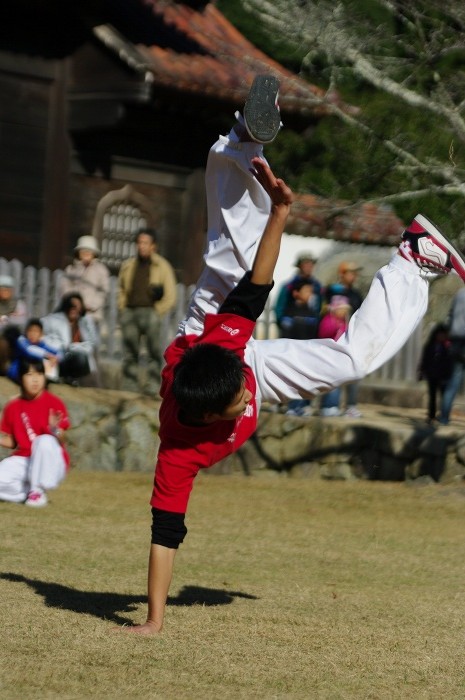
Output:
top-left (250, 158), bottom-right (294, 284)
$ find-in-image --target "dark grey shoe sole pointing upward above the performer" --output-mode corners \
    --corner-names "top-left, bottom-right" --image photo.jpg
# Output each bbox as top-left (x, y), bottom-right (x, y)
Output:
top-left (244, 75), bottom-right (281, 143)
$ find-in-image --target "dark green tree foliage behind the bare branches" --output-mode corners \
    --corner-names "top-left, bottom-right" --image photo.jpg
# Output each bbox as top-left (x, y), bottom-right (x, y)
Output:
top-left (218, 0), bottom-right (465, 236)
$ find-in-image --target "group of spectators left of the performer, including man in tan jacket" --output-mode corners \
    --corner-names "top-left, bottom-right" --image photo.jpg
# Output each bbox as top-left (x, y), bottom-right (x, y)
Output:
top-left (0, 227), bottom-right (176, 396)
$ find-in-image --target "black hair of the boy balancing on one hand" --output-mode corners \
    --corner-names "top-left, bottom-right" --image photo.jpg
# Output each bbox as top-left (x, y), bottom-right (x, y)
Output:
top-left (173, 343), bottom-right (244, 421)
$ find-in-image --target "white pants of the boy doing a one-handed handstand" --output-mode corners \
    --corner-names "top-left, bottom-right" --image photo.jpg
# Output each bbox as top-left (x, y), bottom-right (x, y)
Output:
top-left (180, 129), bottom-right (428, 403)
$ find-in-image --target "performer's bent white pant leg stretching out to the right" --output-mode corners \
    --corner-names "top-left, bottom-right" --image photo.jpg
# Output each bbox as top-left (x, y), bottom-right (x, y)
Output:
top-left (245, 254), bottom-right (428, 402)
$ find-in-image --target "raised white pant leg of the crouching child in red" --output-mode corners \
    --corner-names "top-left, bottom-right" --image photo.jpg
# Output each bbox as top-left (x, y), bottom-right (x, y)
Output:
top-left (29, 435), bottom-right (66, 490)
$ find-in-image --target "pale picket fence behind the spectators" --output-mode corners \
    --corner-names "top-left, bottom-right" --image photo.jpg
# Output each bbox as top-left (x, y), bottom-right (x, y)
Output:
top-left (0, 258), bottom-right (422, 382)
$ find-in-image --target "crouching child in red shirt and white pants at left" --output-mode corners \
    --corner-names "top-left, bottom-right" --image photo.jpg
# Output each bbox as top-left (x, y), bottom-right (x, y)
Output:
top-left (0, 359), bottom-right (70, 508)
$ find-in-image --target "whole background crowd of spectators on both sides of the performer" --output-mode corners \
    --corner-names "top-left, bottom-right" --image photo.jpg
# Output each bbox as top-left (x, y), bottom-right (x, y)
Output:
top-left (0, 205), bottom-right (465, 425)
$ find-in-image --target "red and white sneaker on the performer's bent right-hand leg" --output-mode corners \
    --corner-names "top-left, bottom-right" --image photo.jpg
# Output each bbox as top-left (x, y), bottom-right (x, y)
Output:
top-left (399, 214), bottom-right (465, 282)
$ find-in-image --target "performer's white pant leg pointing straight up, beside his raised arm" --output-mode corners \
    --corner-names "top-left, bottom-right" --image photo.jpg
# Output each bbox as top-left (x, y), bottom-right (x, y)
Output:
top-left (179, 135), bottom-right (270, 335)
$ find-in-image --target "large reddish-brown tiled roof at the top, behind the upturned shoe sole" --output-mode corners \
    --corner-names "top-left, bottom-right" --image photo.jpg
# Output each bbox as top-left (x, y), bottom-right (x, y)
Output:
top-left (95, 0), bottom-right (352, 117)
